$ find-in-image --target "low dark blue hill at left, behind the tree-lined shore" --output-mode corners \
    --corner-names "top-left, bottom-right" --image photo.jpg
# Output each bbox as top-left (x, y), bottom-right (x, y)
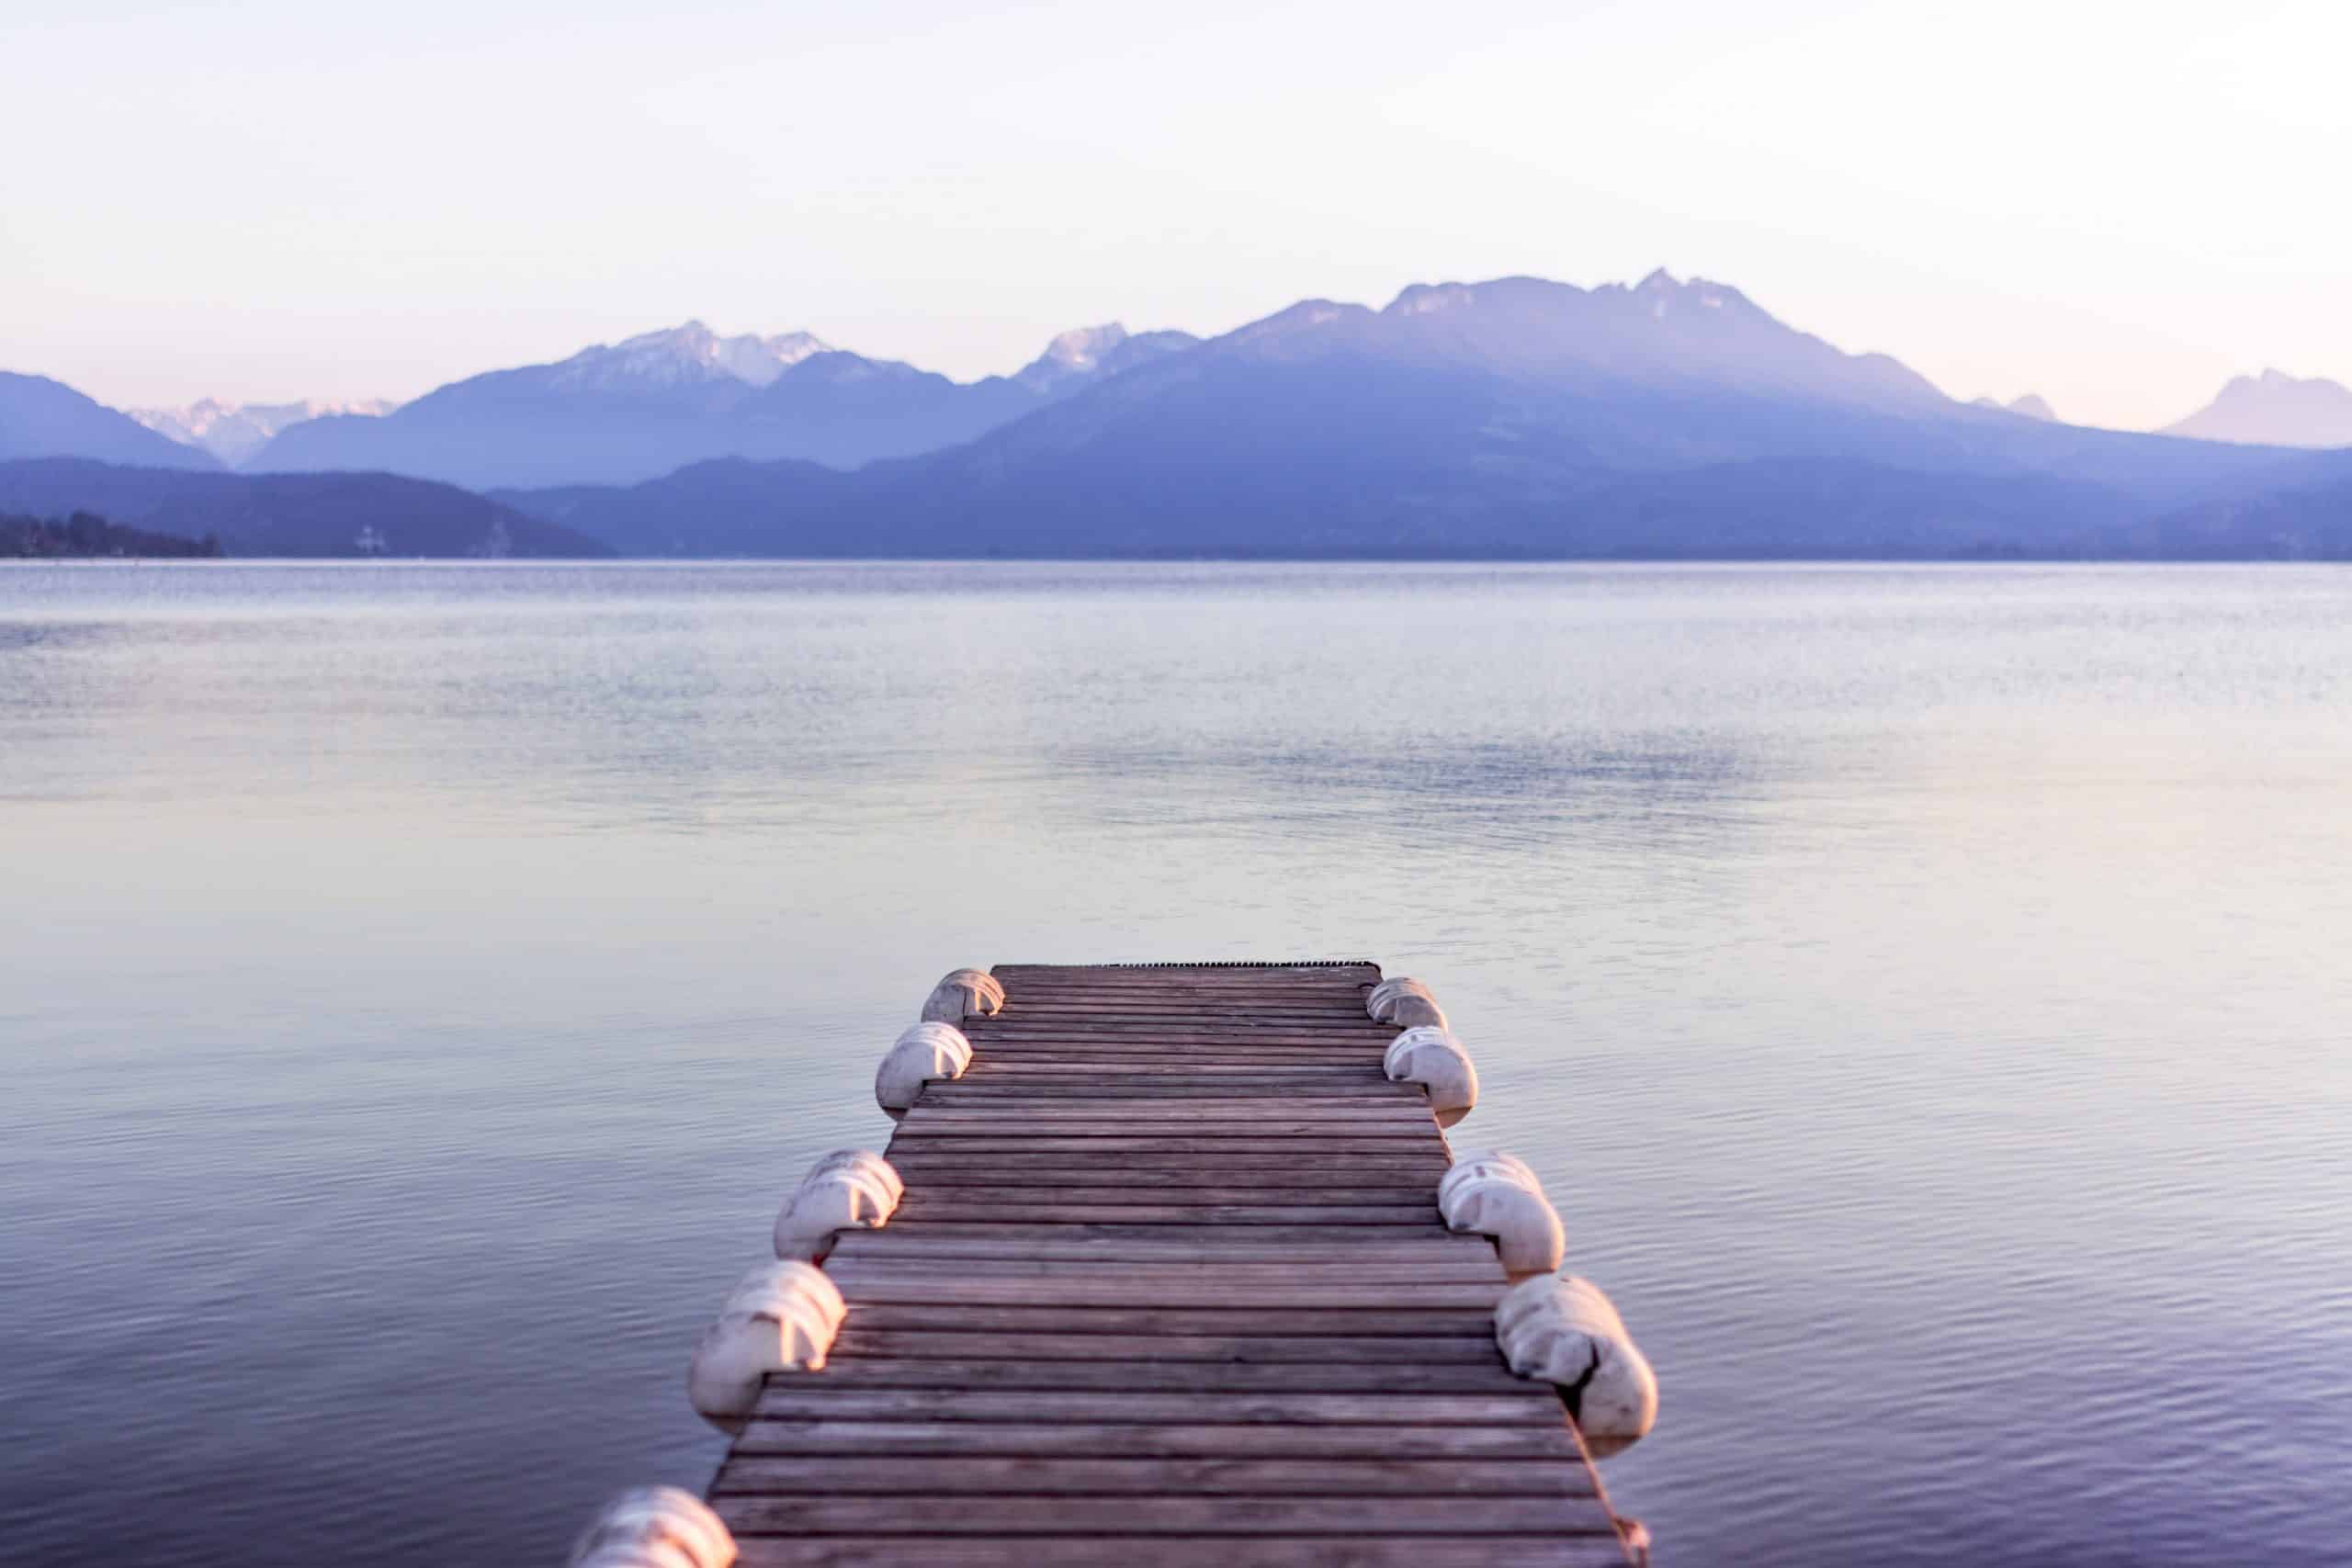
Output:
top-left (0, 456), bottom-right (612, 558)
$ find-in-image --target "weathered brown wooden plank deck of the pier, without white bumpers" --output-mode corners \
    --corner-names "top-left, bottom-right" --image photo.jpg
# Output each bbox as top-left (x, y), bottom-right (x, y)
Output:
top-left (710, 964), bottom-right (1628, 1568)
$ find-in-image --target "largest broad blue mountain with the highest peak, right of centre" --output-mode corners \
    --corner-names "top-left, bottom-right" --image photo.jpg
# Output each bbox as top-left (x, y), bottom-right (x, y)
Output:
top-left (508, 273), bottom-right (2284, 558)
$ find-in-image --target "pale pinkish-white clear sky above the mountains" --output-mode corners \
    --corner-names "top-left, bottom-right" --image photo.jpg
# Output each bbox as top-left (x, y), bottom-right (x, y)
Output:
top-left (0, 0), bottom-right (2352, 428)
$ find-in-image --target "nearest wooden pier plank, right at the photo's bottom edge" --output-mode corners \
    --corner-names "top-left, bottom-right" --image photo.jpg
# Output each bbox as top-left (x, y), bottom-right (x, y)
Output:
top-left (736, 1533), bottom-right (1630, 1568)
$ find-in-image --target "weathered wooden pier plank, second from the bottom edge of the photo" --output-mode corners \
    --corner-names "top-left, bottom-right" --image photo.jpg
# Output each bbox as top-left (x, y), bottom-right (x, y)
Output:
top-left (719, 1495), bottom-right (1616, 1540)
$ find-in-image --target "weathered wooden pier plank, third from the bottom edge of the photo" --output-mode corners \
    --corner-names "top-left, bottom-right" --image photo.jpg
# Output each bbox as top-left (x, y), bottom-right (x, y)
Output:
top-left (710, 1455), bottom-right (1595, 1497)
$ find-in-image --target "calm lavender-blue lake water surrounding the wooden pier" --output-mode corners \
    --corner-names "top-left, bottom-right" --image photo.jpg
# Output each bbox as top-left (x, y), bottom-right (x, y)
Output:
top-left (0, 564), bottom-right (2352, 1568)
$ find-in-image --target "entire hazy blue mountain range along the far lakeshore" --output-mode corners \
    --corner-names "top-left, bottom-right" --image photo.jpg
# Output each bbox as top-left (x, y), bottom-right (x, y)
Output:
top-left (0, 270), bottom-right (2347, 559)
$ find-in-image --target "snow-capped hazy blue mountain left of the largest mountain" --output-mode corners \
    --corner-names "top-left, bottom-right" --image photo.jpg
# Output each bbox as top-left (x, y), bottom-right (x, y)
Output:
top-left (247, 322), bottom-right (1193, 489)
